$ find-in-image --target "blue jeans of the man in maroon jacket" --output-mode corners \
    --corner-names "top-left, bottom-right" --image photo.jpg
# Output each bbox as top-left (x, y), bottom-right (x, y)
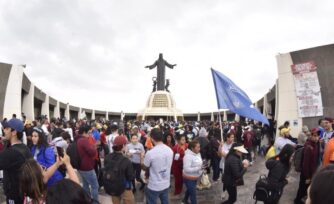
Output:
top-left (79, 169), bottom-right (99, 203)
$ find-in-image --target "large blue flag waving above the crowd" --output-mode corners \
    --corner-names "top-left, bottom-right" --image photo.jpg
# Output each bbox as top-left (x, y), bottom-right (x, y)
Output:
top-left (211, 68), bottom-right (269, 125)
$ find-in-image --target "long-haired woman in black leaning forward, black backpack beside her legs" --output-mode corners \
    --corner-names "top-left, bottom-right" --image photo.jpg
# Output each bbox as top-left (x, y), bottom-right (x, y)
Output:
top-left (265, 144), bottom-right (295, 204)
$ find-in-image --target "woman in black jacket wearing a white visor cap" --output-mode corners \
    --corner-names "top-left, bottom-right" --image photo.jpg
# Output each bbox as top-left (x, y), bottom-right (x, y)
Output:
top-left (223, 143), bottom-right (249, 204)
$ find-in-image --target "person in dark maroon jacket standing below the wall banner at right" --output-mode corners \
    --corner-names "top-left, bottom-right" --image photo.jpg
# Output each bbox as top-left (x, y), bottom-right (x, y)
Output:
top-left (294, 128), bottom-right (320, 204)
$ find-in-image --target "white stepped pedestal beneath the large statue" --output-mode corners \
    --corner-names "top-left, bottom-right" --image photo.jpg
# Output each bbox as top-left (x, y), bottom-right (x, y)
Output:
top-left (137, 91), bottom-right (183, 121)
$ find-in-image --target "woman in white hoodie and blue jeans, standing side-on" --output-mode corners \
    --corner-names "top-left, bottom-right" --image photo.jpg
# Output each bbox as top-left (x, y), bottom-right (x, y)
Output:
top-left (182, 140), bottom-right (203, 204)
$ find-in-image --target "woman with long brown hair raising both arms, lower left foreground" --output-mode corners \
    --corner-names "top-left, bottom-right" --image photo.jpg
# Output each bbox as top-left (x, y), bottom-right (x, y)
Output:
top-left (20, 153), bottom-right (79, 204)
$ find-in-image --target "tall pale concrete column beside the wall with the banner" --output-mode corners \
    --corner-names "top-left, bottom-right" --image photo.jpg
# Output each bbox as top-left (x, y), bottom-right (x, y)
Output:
top-left (276, 53), bottom-right (303, 138)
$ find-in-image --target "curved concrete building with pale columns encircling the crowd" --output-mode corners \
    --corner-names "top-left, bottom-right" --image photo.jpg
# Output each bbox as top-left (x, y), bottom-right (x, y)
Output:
top-left (0, 44), bottom-right (334, 136)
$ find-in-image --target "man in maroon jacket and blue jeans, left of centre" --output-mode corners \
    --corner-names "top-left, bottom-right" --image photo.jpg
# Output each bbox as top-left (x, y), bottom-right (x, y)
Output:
top-left (76, 125), bottom-right (99, 203)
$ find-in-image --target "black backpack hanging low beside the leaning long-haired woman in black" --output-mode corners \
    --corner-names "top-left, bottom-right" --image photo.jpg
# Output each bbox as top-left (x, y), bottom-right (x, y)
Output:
top-left (253, 175), bottom-right (275, 203)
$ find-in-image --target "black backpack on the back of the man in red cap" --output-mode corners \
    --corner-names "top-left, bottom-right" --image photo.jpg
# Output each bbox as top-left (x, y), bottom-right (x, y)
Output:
top-left (102, 154), bottom-right (127, 196)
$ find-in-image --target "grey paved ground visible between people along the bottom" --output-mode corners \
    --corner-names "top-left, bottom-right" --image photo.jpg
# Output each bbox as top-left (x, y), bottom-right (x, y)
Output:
top-left (0, 157), bottom-right (299, 204)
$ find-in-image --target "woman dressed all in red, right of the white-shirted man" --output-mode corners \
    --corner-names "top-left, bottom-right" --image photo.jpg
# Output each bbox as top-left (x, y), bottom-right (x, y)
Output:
top-left (172, 135), bottom-right (187, 195)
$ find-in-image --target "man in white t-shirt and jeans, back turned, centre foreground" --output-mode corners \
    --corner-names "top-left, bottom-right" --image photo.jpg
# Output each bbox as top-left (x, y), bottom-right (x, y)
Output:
top-left (141, 128), bottom-right (173, 204)
